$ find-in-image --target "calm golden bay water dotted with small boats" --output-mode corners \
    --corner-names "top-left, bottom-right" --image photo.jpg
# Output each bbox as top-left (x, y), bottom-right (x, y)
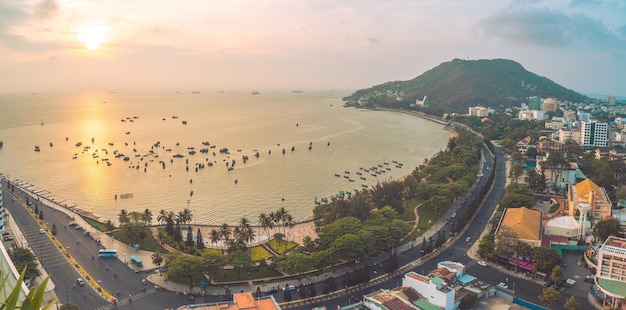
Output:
top-left (0, 90), bottom-right (448, 225)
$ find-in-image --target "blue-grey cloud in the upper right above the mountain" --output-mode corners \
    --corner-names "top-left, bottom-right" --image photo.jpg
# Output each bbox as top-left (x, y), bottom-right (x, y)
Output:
top-left (478, 6), bottom-right (626, 49)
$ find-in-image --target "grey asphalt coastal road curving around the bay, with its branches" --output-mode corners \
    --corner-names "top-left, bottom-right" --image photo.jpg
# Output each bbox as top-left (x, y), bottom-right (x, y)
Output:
top-left (3, 142), bottom-right (587, 309)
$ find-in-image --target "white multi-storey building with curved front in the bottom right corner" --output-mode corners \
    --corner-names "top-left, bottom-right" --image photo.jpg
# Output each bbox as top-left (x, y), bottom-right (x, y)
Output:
top-left (595, 236), bottom-right (626, 309)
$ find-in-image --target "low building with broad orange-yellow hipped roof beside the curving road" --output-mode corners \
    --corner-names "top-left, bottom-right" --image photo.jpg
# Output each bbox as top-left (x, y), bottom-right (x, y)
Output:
top-left (496, 207), bottom-right (541, 248)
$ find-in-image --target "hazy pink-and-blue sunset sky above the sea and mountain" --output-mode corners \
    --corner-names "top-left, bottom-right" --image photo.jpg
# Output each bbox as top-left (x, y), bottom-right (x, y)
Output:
top-left (0, 0), bottom-right (626, 96)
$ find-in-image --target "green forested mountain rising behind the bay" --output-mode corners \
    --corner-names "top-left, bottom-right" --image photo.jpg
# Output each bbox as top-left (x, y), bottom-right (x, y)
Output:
top-left (343, 59), bottom-right (589, 113)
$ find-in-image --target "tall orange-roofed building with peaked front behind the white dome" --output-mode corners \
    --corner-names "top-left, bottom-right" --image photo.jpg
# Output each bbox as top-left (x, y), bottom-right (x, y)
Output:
top-left (567, 179), bottom-right (611, 221)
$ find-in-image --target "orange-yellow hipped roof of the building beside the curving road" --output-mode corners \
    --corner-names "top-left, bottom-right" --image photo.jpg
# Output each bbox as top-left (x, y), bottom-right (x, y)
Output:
top-left (501, 207), bottom-right (541, 240)
